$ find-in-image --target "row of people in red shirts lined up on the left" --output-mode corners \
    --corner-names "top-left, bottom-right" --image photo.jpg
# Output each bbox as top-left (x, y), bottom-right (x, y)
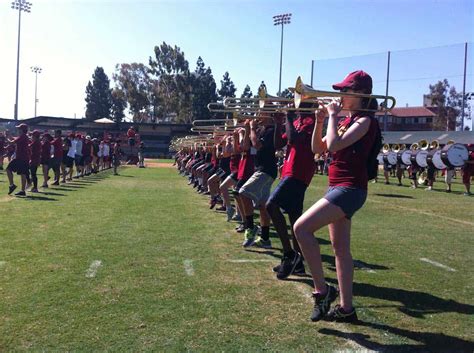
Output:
top-left (0, 123), bottom-right (123, 197)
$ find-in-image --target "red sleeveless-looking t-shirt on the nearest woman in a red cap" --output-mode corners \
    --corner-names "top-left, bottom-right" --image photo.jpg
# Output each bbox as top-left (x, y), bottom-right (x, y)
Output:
top-left (329, 117), bottom-right (378, 190)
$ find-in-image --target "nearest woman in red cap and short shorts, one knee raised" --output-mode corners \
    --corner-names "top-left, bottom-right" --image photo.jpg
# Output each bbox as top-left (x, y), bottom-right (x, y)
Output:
top-left (294, 71), bottom-right (379, 322)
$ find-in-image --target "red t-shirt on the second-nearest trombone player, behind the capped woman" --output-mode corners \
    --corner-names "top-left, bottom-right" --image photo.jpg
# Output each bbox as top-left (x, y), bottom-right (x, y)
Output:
top-left (281, 116), bottom-right (316, 185)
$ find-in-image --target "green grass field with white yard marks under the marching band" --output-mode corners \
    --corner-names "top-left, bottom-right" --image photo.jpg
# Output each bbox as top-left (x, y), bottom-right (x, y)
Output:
top-left (0, 161), bottom-right (474, 352)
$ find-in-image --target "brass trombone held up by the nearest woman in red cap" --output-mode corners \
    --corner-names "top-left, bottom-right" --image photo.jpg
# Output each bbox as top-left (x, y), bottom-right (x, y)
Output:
top-left (295, 76), bottom-right (396, 111)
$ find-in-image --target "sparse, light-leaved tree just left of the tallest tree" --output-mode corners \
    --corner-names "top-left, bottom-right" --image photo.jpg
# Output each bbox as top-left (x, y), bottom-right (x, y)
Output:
top-left (113, 63), bottom-right (155, 121)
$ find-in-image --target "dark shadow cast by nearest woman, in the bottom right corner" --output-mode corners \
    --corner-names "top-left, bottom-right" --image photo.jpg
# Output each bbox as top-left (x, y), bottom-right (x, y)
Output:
top-left (319, 321), bottom-right (474, 352)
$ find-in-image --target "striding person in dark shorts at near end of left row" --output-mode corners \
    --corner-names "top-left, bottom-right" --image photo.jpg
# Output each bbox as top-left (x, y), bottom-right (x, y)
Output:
top-left (7, 124), bottom-right (30, 196)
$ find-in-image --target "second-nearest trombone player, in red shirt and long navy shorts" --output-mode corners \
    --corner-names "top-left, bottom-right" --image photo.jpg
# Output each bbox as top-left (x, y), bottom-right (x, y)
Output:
top-left (266, 108), bottom-right (317, 279)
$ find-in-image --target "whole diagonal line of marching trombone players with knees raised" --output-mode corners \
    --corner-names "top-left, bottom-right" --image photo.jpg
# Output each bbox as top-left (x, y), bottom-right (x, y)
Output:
top-left (175, 71), bottom-right (381, 322)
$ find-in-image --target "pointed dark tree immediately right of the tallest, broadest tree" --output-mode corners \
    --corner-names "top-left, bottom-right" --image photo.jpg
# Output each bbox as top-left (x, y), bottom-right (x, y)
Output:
top-left (191, 57), bottom-right (217, 120)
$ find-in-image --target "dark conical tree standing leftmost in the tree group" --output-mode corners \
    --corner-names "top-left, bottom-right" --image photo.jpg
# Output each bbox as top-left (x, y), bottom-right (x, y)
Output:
top-left (85, 66), bottom-right (112, 120)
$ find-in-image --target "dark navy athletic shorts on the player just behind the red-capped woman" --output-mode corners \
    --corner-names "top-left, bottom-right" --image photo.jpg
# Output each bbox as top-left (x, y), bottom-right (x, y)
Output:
top-left (268, 177), bottom-right (308, 215)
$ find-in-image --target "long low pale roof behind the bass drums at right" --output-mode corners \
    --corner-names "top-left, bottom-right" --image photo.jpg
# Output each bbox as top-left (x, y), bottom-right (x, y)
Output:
top-left (382, 131), bottom-right (474, 145)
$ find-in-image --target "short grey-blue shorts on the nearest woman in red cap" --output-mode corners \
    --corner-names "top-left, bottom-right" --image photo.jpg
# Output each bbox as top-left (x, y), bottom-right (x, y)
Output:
top-left (324, 186), bottom-right (367, 219)
